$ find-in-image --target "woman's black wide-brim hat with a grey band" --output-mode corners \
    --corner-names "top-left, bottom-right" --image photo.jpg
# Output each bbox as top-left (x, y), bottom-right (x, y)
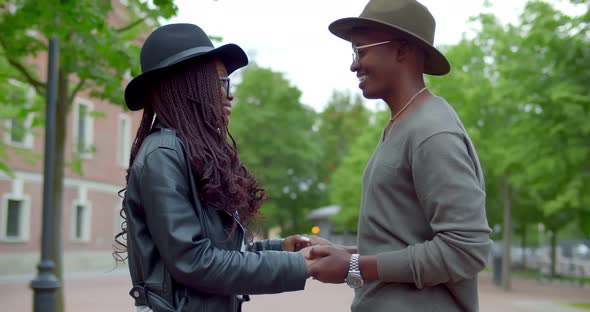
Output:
top-left (125, 24), bottom-right (248, 111)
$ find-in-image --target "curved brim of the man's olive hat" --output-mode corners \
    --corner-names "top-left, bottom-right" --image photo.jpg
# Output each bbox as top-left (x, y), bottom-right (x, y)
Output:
top-left (328, 17), bottom-right (451, 76)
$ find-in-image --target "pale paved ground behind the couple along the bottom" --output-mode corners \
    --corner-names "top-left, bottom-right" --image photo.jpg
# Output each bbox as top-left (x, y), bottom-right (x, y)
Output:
top-left (0, 270), bottom-right (590, 312)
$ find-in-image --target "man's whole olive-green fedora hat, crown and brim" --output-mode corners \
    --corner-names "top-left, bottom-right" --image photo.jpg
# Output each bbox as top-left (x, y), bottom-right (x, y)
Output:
top-left (329, 0), bottom-right (451, 76)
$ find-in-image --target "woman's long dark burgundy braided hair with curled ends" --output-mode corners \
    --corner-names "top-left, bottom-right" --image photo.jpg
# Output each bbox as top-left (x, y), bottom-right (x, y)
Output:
top-left (113, 59), bottom-right (264, 261)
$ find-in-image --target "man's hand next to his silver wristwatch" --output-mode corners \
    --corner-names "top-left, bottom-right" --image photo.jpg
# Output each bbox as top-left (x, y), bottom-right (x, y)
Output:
top-left (304, 246), bottom-right (350, 284)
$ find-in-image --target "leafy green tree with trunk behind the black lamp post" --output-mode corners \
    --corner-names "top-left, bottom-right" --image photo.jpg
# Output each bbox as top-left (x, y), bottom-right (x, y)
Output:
top-left (0, 0), bottom-right (176, 311)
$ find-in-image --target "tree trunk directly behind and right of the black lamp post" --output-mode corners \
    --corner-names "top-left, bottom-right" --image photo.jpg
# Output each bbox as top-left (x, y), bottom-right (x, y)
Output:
top-left (51, 68), bottom-right (69, 312)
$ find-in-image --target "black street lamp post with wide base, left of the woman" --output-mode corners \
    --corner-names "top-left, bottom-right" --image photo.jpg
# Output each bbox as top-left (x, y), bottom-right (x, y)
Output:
top-left (31, 36), bottom-right (61, 312)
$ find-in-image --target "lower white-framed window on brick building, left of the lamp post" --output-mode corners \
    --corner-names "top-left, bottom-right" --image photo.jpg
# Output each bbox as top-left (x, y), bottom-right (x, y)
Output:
top-left (0, 195), bottom-right (29, 242)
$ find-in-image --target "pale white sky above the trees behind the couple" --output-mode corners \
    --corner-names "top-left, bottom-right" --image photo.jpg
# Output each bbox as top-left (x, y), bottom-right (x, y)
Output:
top-left (163, 0), bottom-right (576, 111)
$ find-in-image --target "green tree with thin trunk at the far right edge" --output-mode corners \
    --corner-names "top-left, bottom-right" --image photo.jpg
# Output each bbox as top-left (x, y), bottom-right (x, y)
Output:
top-left (506, 1), bottom-right (590, 275)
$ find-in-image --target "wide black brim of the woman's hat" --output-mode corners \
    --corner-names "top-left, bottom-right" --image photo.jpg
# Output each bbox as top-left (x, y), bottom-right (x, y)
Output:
top-left (125, 43), bottom-right (248, 111)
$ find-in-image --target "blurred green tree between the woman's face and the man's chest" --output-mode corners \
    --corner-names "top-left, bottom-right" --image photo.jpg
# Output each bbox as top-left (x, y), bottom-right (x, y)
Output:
top-left (230, 64), bottom-right (321, 235)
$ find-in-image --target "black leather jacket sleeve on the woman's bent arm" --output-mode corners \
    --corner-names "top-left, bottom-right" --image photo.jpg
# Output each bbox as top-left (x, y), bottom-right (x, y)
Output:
top-left (136, 148), bottom-right (306, 294)
